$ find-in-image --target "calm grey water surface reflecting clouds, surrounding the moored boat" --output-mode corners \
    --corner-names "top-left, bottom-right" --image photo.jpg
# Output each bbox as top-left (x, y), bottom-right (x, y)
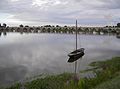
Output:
top-left (0, 33), bottom-right (120, 85)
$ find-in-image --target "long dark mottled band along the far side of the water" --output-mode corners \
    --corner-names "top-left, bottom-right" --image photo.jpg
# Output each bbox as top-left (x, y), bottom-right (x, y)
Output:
top-left (0, 26), bottom-right (120, 35)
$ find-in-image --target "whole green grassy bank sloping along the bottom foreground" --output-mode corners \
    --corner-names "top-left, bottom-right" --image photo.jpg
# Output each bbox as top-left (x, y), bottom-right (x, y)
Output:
top-left (1, 57), bottom-right (120, 89)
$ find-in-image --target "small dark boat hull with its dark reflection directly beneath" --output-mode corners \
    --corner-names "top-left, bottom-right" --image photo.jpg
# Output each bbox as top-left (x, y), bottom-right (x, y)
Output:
top-left (68, 48), bottom-right (85, 62)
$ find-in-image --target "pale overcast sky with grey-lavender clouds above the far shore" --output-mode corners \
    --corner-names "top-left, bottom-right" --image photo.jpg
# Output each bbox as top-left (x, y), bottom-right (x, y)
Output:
top-left (0, 0), bottom-right (120, 26)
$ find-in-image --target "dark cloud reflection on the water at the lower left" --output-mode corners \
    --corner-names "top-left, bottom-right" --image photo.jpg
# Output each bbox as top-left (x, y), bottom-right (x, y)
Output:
top-left (0, 66), bottom-right (27, 85)
